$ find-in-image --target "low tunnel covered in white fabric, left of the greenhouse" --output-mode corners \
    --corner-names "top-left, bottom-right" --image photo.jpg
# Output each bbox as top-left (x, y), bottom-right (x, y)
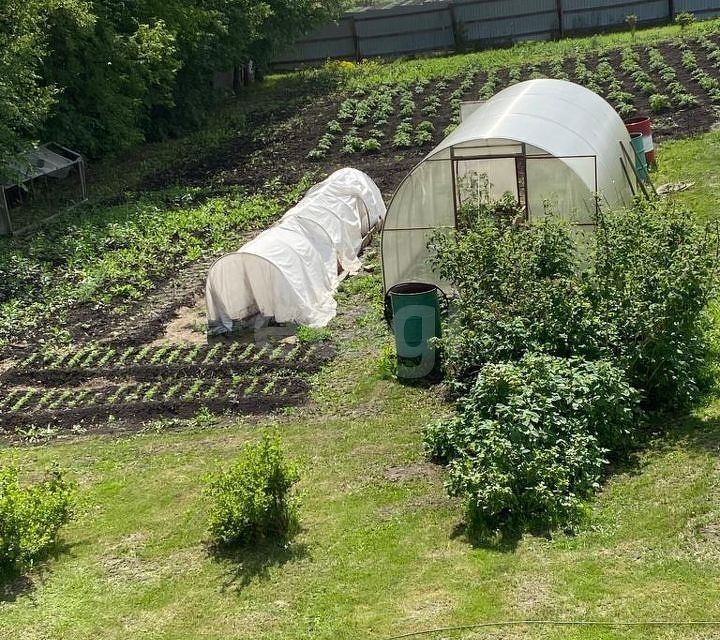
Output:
top-left (205, 168), bottom-right (386, 332)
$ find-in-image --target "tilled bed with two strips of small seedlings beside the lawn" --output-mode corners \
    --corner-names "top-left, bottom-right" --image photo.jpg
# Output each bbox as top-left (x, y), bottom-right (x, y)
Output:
top-left (0, 342), bottom-right (333, 438)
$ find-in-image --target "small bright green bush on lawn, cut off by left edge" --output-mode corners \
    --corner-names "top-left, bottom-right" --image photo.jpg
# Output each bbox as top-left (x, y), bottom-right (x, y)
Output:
top-left (0, 465), bottom-right (75, 572)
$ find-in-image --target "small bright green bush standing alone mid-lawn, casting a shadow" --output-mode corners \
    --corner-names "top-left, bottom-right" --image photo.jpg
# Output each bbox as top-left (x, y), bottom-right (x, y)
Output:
top-left (207, 434), bottom-right (299, 546)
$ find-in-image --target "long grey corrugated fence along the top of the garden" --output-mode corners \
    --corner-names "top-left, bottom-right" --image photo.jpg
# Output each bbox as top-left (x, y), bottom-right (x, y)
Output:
top-left (275, 0), bottom-right (720, 69)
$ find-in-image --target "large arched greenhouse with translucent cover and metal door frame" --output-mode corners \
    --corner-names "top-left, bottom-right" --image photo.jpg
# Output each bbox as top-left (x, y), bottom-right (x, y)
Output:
top-left (382, 79), bottom-right (633, 290)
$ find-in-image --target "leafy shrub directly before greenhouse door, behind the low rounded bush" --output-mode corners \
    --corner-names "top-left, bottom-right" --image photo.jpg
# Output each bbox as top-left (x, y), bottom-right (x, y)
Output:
top-left (431, 212), bottom-right (600, 384)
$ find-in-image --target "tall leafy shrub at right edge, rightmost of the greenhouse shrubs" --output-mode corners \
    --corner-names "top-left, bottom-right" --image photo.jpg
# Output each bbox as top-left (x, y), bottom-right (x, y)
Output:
top-left (584, 204), bottom-right (717, 409)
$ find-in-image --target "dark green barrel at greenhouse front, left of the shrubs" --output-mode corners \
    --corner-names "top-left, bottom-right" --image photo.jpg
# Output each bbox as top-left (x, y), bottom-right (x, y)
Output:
top-left (386, 282), bottom-right (444, 379)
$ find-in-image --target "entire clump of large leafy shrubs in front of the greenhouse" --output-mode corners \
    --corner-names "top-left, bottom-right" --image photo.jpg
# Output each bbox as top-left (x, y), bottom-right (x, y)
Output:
top-left (426, 194), bottom-right (716, 530)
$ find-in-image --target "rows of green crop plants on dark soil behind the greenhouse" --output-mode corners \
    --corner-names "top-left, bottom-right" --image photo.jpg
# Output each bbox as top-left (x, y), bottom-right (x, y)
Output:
top-left (308, 35), bottom-right (717, 160)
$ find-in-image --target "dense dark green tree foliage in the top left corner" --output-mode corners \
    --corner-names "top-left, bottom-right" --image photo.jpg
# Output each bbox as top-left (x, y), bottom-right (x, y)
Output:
top-left (0, 0), bottom-right (341, 161)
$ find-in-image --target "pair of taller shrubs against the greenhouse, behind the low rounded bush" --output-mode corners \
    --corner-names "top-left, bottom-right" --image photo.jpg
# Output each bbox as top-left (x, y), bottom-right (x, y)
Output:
top-left (431, 198), bottom-right (715, 408)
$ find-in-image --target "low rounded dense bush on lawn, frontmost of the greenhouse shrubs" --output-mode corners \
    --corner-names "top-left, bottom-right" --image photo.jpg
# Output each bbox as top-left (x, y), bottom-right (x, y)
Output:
top-left (425, 355), bottom-right (641, 531)
